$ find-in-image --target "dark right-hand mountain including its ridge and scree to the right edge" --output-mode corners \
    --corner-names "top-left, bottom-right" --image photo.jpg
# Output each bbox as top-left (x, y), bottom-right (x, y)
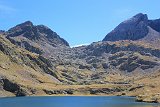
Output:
top-left (103, 13), bottom-right (160, 46)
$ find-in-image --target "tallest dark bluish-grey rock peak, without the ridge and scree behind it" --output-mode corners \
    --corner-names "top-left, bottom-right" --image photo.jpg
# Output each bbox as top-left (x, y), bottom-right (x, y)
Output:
top-left (103, 13), bottom-right (148, 41)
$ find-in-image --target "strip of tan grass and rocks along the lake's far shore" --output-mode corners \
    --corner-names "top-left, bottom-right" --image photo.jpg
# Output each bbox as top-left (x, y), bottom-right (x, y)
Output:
top-left (0, 84), bottom-right (160, 103)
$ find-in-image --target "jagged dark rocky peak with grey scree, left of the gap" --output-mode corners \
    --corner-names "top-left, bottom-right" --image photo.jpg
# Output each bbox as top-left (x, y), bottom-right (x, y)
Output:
top-left (6, 21), bottom-right (69, 53)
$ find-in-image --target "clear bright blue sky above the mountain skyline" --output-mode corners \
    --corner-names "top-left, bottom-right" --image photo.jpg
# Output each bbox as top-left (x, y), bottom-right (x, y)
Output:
top-left (0, 0), bottom-right (160, 46)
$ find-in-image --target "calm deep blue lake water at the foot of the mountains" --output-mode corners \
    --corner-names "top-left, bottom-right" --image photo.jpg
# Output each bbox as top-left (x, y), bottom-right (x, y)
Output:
top-left (0, 96), bottom-right (160, 107)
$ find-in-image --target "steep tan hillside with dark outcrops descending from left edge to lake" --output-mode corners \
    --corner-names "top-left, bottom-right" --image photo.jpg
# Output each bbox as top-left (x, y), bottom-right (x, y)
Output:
top-left (0, 35), bottom-right (64, 96)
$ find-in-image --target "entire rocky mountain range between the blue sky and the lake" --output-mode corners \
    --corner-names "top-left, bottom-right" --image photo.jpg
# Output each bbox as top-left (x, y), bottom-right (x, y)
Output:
top-left (0, 13), bottom-right (160, 102)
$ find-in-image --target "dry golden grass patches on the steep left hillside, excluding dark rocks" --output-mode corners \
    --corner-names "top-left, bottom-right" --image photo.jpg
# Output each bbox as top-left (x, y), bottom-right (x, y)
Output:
top-left (0, 36), bottom-right (59, 96)
